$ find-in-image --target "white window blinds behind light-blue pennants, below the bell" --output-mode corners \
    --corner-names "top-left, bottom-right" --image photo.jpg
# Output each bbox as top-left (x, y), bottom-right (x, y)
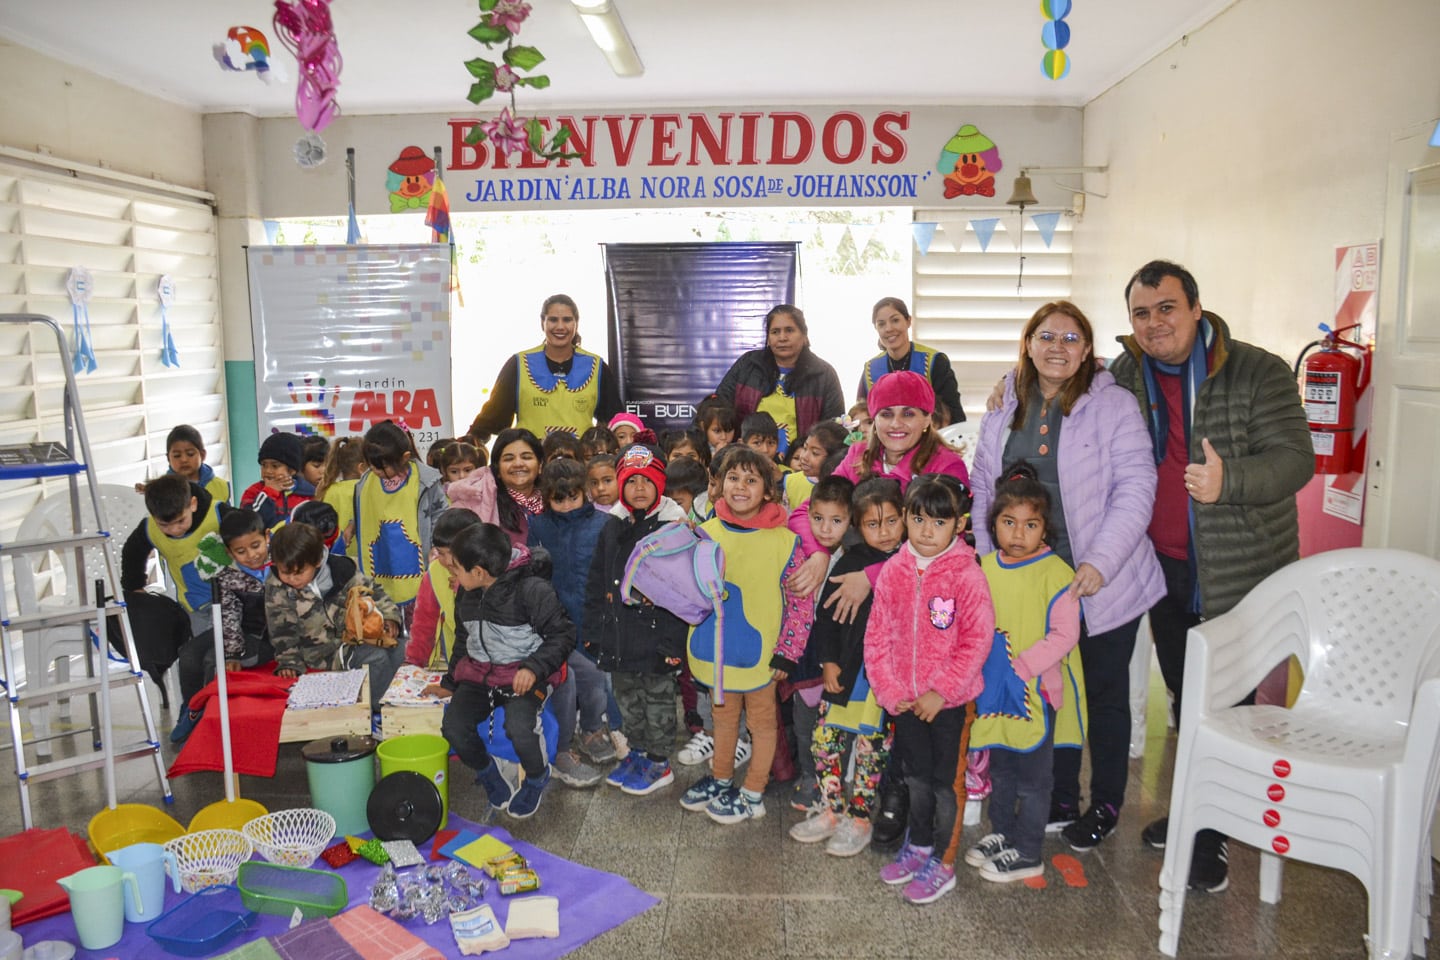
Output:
top-left (910, 209), bottom-right (1073, 420)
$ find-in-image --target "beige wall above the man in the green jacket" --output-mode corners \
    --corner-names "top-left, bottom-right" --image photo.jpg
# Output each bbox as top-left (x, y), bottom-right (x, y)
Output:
top-left (1074, 0), bottom-right (1440, 357)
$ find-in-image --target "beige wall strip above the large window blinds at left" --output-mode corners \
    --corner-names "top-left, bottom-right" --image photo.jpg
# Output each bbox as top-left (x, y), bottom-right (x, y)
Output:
top-left (0, 39), bottom-right (204, 190)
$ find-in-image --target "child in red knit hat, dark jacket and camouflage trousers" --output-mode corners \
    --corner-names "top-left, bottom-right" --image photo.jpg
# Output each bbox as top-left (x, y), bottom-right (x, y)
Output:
top-left (585, 443), bottom-right (688, 796)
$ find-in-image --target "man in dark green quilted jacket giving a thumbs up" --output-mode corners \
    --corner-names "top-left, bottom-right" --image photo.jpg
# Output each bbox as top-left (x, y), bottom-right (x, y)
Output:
top-left (1110, 261), bottom-right (1315, 892)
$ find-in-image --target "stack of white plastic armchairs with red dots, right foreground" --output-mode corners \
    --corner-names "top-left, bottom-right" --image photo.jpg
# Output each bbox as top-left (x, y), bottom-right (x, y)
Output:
top-left (1159, 550), bottom-right (1440, 960)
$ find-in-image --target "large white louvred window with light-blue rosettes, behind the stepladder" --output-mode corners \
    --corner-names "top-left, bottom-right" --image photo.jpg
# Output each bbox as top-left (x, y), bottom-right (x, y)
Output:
top-left (0, 163), bottom-right (229, 531)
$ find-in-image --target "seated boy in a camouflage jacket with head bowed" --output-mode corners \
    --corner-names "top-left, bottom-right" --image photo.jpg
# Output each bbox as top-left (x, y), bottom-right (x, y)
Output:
top-left (265, 524), bottom-right (405, 710)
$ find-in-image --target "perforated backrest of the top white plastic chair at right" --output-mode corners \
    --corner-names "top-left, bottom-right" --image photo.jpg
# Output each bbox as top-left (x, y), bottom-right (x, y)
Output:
top-left (1286, 548), bottom-right (1440, 723)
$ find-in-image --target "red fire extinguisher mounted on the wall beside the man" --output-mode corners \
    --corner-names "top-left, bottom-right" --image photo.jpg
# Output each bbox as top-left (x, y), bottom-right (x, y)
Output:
top-left (1295, 324), bottom-right (1371, 474)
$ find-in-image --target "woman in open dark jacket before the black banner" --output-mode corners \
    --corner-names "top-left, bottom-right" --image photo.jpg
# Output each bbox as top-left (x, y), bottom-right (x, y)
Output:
top-left (716, 304), bottom-right (845, 456)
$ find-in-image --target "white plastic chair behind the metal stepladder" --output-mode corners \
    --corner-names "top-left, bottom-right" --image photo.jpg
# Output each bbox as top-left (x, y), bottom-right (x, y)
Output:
top-left (13, 484), bottom-right (145, 757)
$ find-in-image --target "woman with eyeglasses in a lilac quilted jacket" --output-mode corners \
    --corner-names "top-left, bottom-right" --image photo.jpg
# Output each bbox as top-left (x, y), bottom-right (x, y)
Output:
top-left (971, 301), bottom-right (1157, 851)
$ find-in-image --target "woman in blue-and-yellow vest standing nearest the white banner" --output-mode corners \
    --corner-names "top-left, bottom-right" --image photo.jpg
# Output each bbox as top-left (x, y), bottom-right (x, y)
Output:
top-left (469, 294), bottom-right (624, 443)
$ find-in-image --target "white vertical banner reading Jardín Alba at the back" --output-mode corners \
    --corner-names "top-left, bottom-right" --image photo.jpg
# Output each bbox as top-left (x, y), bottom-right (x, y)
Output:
top-left (248, 243), bottom-right (455, 456)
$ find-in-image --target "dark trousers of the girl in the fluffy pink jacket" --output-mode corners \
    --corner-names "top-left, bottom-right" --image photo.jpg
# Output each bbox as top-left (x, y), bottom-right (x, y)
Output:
top-left (894, 707), bottom-right (973, 856)
